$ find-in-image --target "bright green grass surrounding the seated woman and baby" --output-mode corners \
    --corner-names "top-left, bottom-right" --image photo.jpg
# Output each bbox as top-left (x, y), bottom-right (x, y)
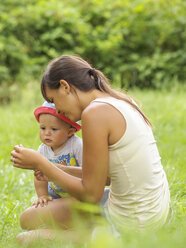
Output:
top-left (0, 83), bottom-right (186, 248)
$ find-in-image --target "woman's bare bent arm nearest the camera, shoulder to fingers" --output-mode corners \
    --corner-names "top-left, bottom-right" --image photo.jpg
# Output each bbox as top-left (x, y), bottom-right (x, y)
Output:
top-left (11, 104), bottom-right (116, 203)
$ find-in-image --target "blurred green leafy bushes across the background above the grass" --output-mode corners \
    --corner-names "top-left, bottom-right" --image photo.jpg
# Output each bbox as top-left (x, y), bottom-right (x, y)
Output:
top-left (0, 0), bottom-right (186, 95)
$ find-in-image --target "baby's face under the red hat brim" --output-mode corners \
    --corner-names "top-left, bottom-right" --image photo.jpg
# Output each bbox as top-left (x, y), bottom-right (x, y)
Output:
top-left (39, 114), bottom-right (70, 152)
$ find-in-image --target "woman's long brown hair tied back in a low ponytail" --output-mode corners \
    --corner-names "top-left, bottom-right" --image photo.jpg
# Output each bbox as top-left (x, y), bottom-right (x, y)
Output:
top-left (41, 55), bottom-right (151, 126)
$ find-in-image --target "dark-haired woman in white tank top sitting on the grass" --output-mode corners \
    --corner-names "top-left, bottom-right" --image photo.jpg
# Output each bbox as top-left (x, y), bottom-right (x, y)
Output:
top-left (11, 55), bottom-right (170, 242)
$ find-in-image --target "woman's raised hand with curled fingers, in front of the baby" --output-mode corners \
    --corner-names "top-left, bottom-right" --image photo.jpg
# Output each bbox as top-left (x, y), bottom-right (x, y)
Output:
top-left (10, 145), bottom-right (42, 170)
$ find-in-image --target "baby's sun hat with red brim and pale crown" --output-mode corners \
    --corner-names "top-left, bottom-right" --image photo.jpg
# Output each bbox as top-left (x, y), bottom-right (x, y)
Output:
top-left (34, 101), bottom-right (81, 132)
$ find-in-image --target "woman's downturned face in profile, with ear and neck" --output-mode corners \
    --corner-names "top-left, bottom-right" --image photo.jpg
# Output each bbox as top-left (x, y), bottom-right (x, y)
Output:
top-left (46, 84), bottom-right (82, 122)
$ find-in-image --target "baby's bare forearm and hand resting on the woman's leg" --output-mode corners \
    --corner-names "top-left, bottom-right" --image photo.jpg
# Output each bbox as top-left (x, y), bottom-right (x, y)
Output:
top-left (32, 177), bottom-right (52, 208)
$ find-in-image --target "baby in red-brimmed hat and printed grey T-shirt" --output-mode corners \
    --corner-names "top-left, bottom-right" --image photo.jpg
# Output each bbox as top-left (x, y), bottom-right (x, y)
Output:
top-left (32, 102), bottom-right (82, 207)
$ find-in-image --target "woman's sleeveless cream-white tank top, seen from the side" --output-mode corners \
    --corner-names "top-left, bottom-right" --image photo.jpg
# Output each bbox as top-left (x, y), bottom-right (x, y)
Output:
top-left (94, 97), bottom-right (170, 229)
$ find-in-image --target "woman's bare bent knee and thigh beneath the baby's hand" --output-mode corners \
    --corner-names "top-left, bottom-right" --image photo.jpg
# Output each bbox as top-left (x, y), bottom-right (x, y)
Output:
top-left (20, 197), bottom-right (77, 230)
